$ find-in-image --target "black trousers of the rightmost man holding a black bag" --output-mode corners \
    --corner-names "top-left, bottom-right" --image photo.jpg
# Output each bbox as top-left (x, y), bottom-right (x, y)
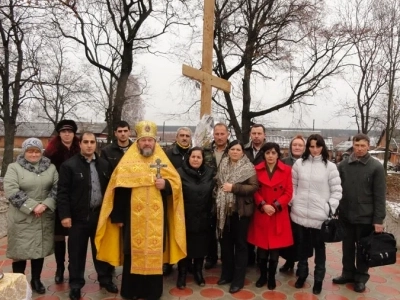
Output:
top-left (342, 221), bottom-right (374, 283)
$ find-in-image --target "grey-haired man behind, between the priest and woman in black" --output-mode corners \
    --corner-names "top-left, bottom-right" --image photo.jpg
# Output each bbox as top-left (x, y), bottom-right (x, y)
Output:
top-left (163, 127), bottom-right (192, 276)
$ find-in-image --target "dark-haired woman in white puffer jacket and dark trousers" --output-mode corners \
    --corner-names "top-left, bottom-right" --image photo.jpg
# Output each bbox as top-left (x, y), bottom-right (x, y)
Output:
top-left (290, 134), bottom-right (342, 295)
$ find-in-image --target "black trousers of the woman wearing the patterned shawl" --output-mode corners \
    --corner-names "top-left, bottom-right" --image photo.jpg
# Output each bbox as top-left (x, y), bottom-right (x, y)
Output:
top-left (220, 213), bottom-right (250, 288)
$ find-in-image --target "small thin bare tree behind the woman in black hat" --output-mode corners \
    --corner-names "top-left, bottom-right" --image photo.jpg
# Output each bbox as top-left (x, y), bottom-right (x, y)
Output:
top-left (29, 37), bottom-right (94, 127)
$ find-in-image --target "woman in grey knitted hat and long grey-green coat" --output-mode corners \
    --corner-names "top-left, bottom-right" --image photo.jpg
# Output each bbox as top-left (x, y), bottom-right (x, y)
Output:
top-left (4, 138), bottom-right (58, 294)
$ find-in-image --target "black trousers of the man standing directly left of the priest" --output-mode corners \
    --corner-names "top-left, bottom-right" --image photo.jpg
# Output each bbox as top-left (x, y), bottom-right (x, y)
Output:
top-left (68, 211), bottom-right (112, 289)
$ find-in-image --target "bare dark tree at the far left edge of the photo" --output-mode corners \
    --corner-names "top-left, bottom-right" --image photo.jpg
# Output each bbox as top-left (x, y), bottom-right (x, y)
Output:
top-left (0, 0), bottom-right (39, 176)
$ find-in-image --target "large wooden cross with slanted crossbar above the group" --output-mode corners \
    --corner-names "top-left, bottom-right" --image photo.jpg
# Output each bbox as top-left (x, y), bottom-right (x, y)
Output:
top-left (182, 0), bottom-right (231, 118)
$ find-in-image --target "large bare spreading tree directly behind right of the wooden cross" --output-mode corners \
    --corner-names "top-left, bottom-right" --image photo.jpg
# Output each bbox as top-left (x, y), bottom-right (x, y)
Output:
top-left (183, 0), bottom-right (351, 142)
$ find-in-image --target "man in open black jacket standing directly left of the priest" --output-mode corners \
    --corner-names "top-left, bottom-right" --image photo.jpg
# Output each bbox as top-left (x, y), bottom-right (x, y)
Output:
top-left (57, 132), bottom-right (118, 300)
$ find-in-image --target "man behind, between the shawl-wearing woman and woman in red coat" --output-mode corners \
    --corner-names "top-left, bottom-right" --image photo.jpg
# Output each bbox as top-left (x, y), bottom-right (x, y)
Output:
top-left (244, 124), bottom-right (265, 266)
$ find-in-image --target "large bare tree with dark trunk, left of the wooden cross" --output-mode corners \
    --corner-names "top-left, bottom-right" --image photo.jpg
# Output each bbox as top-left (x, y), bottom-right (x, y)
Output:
top-left (53, 0), bottom-right (190, 136)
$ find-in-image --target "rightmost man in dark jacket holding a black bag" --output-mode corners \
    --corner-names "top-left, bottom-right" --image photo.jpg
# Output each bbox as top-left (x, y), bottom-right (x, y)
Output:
top-left (332, 133), bottom-right (386, 293)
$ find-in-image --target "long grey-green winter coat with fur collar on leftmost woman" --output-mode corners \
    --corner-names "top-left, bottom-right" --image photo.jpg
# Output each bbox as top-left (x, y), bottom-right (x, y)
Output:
top-left (4, 156), bottom-right (58, 260)
